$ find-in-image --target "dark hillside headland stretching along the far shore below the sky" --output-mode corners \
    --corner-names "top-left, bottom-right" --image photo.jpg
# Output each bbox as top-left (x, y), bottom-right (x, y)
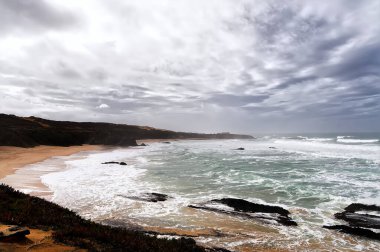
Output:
top-left (0, 114), bottom-right (253, 147)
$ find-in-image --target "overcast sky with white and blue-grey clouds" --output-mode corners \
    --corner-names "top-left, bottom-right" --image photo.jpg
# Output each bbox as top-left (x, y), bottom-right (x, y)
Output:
top-left (0, 0), bottom-right (380, 133)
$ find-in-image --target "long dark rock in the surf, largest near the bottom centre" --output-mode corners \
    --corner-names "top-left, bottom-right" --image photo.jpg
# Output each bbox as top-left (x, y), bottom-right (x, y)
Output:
top-left (189, 198), bottom-right (297, 226)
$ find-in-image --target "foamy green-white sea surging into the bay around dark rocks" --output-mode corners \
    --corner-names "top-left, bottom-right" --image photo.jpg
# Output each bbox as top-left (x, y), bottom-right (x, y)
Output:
top-left (3, 134), bottom-right (380, 251)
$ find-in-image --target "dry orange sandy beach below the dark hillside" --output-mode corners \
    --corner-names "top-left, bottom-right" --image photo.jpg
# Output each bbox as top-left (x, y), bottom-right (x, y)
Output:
top-left (0, 145), bottom-right (103, 179)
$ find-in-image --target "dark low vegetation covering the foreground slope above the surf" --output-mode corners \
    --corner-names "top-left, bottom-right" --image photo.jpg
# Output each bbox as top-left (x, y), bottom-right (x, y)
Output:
top-left (0, 184), bottom-right (210, 252)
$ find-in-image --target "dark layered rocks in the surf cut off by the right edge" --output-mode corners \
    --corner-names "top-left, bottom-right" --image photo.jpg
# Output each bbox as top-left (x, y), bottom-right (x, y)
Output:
top-left (324, 203), bottom-right (380, 240)
